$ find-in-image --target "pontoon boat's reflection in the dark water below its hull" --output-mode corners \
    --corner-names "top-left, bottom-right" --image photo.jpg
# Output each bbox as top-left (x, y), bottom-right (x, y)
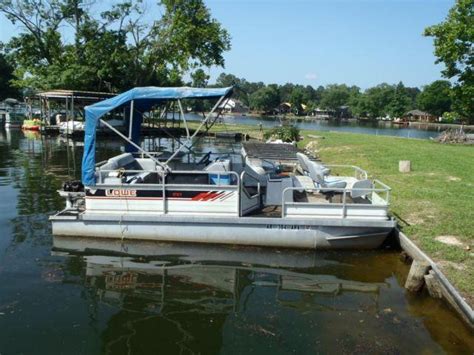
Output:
top-left (54, 236), bottom-right (390, 313)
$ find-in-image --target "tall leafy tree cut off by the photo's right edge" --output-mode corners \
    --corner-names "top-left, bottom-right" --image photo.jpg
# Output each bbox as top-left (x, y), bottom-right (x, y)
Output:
top-left (424, 0), bottom-right (474, 122)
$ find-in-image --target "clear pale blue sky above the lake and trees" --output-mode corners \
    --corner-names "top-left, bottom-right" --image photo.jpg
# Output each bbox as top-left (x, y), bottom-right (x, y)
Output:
top-left (0, 0), bottom-right (454, 89)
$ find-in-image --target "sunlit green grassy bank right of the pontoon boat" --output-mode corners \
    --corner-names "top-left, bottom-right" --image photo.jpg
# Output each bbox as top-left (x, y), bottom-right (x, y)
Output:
top-left (198, 125), bottom-right (474, 305)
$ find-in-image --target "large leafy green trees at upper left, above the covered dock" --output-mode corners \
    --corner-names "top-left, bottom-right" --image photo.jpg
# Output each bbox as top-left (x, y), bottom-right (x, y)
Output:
top-left (0, 0), bottom-right (230, 91)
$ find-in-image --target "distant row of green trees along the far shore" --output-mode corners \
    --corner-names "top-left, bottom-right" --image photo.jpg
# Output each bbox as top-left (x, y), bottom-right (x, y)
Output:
top-left (216, 73), bottom-right (453, 119)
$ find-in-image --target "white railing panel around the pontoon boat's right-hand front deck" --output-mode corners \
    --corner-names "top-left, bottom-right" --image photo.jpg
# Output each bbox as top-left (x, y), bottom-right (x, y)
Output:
top-left (281, 179), bottom-right (391, 218)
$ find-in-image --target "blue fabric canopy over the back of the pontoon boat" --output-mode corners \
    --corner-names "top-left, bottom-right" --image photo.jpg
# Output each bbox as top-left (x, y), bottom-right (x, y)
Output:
top-left (82, 86), bottom-right (232, 186)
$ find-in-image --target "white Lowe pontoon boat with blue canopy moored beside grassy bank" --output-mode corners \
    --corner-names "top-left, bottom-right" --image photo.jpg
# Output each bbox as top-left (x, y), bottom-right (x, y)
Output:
top-left (50, 87), bottom-right (396, 249)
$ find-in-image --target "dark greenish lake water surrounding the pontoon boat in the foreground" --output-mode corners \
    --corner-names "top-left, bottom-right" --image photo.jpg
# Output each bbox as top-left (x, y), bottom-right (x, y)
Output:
top-left (0, 131), bottom-right (474, 355)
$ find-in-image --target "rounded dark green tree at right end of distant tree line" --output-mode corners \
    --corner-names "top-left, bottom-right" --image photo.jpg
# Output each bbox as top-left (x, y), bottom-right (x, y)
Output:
top-left (417, 80), bottom-right (452, 117)
